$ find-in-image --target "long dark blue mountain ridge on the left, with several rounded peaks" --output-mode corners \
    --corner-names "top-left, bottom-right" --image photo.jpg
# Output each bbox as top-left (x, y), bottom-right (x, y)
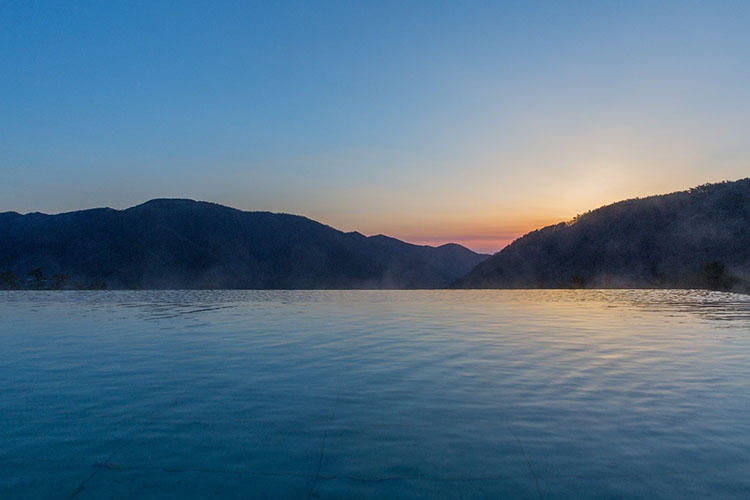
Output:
top-left (0, 199), bottom-right (487, 289)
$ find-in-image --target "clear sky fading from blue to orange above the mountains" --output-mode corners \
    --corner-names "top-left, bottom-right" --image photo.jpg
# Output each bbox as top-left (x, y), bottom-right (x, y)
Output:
top-left (0, 0), bottom-right (750, 252)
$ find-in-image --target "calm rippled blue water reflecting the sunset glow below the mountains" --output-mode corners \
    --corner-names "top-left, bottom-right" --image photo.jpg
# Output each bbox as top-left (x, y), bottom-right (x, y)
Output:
top-left (0, 291), bottom-right (750, 499)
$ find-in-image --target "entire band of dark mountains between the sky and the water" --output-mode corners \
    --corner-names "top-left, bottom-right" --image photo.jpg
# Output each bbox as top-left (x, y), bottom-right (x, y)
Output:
top-left (0, 179), bottom-right (750, 292)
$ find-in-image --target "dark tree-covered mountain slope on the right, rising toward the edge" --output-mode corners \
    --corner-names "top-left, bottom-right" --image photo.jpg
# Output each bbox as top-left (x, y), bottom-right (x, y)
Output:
top-left (453, 179), bottom-right (750, 291)
